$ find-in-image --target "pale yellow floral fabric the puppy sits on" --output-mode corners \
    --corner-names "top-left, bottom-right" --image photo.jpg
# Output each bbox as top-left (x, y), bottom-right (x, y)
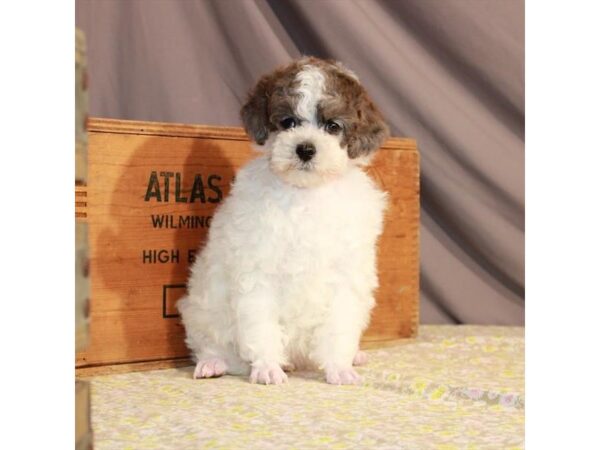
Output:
top-left (86, 326), bottom-right (525, 450)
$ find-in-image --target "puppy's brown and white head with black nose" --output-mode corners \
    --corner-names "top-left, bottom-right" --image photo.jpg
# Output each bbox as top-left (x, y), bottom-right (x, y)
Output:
top-left (241, 57), bottom-right (389, 187)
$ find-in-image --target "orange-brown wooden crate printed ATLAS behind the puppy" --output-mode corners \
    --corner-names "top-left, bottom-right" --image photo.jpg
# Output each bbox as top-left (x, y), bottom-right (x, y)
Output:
top-left (76, 119), bottom-right (419, 375)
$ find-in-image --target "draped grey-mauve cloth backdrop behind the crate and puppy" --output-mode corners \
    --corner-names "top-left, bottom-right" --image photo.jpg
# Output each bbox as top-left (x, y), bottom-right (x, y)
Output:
top-left (76, 0), bottom-right (524, 324)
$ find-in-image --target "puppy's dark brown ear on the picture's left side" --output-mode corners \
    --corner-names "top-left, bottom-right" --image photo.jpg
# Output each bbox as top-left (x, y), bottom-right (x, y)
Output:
top-left (241, 75), bottom-right (271, 145)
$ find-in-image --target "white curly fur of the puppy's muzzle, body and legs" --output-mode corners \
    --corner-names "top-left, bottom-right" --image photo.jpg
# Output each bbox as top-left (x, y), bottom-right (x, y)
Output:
top-left (178, 64), bottom-right (386, 384)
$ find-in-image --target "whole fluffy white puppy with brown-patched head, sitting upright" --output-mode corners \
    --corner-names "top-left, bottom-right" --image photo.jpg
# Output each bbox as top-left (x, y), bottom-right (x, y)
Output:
top-left (178, 57), bottom-right (388, 384)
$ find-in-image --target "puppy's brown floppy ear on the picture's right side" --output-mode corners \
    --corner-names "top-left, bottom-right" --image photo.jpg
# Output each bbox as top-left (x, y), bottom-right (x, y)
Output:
top-left (348, 95), bottom-right (390, 159)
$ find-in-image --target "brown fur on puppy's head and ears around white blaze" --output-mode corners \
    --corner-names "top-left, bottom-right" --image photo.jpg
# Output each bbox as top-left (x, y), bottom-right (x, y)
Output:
top-left (241, 57), bottom-right (389, 158)
